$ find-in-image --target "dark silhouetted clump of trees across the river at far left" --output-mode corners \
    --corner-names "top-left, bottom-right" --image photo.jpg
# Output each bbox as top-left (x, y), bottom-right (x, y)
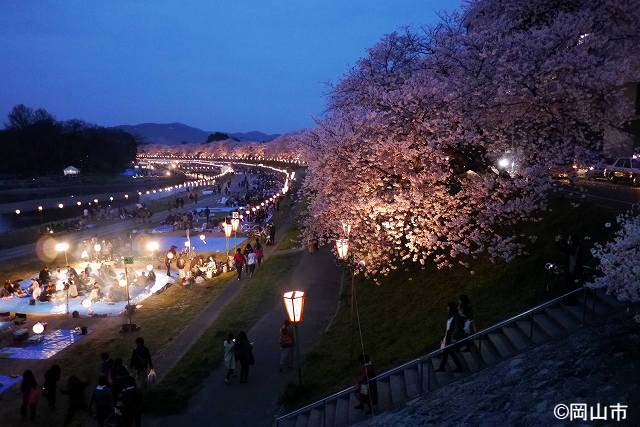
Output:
top-left (0, 105), bottom-right (139, 177)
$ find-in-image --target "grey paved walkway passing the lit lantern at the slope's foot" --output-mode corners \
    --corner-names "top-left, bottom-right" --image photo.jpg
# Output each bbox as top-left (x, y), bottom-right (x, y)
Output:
top-left (145, 249), bottom-right (340, 426)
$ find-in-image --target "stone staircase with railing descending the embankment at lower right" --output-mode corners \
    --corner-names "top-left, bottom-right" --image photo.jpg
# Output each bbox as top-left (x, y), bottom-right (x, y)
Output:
top-left (275, 288), bottom-right (624, 427)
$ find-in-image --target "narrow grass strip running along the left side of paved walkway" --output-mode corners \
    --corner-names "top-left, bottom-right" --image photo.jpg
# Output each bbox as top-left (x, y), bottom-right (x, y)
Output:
top-left (145, 254), bottom-right (300, 415)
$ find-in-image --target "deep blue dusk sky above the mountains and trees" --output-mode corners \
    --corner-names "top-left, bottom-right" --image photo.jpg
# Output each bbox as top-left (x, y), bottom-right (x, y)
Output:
top-left (0, 0), bottom-right (459, 132)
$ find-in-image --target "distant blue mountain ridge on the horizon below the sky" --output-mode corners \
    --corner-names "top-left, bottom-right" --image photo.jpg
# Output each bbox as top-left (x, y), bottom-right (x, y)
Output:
top-left (114, 123), bottom-right (280, 145)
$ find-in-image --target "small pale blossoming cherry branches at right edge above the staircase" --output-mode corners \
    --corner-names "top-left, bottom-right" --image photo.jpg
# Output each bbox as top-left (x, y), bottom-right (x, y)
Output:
top-left (590, 212), bottom-right (640, 302)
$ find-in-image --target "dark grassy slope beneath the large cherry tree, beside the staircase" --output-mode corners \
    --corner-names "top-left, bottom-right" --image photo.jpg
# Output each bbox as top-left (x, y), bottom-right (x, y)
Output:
top-left (281, 202), bottom-right (615, 408)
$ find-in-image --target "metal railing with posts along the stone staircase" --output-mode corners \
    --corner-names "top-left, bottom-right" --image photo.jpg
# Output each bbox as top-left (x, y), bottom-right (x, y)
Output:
top-left (275, 287), bottom-right (596, 427)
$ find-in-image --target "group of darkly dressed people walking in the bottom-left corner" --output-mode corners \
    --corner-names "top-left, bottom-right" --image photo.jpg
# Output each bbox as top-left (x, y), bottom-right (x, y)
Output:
top-left (20, 337), bottom-right (155, 427)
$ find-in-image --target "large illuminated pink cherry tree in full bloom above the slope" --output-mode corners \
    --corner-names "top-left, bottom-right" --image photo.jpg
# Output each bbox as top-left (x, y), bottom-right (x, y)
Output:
top-left (305, 0), bottom-right (640, 274)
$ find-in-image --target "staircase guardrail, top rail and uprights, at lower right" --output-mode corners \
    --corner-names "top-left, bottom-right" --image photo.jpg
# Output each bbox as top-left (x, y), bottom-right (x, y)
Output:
top-left (275, 287), bottom-right (596, 427)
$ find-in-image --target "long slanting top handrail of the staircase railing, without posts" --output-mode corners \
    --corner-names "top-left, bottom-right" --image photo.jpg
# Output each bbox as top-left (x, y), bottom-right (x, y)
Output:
top-left (276, 286), bottom-right (591, 425)
